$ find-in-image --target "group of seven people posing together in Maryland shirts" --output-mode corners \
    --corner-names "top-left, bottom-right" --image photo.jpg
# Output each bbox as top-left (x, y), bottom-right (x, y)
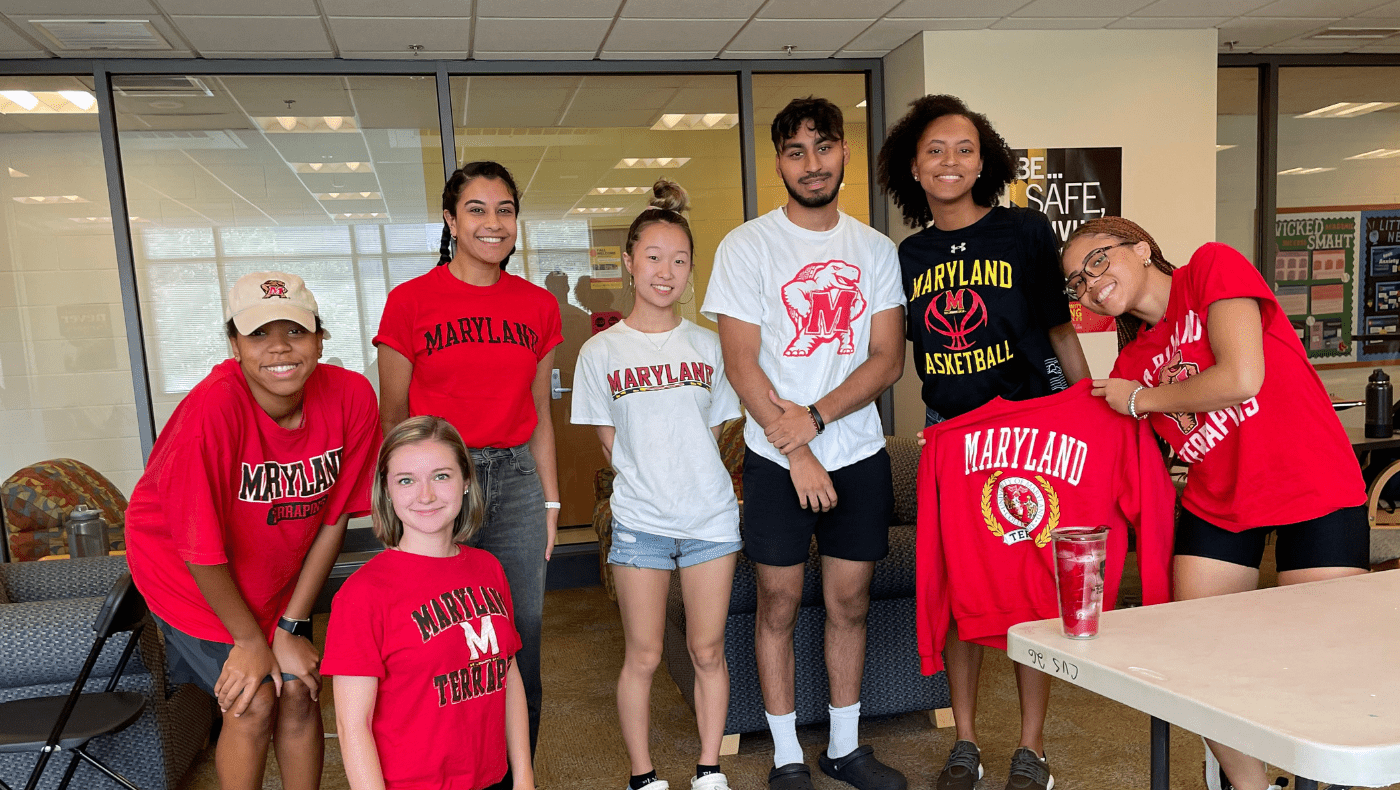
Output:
top-left (117, 95), bottom-right (1368, 790)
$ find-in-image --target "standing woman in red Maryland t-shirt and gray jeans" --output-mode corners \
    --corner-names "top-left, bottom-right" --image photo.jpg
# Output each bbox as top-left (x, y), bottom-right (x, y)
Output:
top-left (374, 162), bottom-right (563, 767)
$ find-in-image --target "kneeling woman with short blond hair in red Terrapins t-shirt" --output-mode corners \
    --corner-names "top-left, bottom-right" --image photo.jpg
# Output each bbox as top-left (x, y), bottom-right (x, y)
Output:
top-left (323, 416), bottom-right (535, 790)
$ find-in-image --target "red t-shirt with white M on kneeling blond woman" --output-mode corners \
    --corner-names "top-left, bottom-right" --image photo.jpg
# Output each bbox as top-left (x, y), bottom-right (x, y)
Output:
top-left (321, 546), bottom-right (521, 790)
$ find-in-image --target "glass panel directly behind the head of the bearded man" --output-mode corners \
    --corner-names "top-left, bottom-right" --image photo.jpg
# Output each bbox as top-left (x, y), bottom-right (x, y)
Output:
top-left (753, 74), bottom-right (871, 223)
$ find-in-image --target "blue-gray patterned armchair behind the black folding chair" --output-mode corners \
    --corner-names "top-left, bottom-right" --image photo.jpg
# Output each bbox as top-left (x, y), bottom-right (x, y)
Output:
top-left (0, 557), bottom-right (213, 790)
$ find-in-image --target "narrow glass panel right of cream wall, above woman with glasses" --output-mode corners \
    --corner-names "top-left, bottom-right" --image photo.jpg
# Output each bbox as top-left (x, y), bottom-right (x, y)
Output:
top-left (1215, 69), bottom-right (1259, 261)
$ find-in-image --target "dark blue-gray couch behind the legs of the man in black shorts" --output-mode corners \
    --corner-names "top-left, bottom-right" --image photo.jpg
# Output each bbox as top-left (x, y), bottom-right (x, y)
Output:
top-left (665, 437), bottom-right (949, 735)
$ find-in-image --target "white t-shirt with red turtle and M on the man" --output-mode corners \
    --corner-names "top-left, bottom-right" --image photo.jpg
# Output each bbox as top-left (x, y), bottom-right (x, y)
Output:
top-left (701, 209), bottom-right (904, 471)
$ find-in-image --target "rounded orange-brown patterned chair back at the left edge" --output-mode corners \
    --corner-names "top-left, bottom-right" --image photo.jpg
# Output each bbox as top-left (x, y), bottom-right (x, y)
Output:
top-left (0, 458), bottom-right (126, 562)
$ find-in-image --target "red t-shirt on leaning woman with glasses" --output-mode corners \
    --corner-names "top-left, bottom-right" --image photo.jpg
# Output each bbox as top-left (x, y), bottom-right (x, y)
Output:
top-left (1112, 242), bottom-right (1366, 532)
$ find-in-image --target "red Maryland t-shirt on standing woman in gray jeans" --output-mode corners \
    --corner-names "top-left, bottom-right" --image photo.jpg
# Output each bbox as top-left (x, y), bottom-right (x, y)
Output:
top-left (374, 266), bottom-right (564, 447)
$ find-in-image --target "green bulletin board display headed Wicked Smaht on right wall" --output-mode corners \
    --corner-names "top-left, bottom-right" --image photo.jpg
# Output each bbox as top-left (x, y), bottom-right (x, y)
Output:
top-left (1274, 209), bottom-right (1355, 363)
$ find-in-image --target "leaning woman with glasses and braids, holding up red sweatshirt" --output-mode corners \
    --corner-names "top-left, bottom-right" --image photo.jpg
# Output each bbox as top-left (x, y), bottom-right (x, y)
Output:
top-left (1061, 217), bottom-right (1369, 790)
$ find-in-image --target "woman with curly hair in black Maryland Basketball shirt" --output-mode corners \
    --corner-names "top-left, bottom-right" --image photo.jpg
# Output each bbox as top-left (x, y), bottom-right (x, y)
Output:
top-left (876, 95), bottom-right (1089, 790)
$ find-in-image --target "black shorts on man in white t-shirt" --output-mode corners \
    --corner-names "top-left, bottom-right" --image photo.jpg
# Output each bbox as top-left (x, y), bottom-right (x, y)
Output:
top-left (743, 447), bottom-right (895, 567)
